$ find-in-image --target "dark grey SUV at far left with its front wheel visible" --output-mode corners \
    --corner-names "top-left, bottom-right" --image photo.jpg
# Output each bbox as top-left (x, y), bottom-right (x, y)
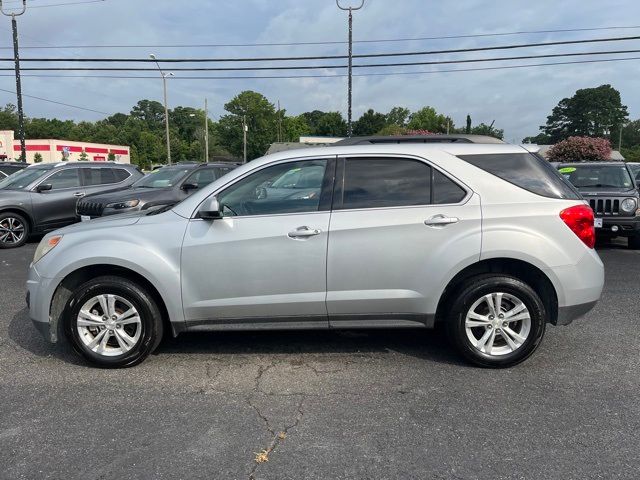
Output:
top-left (0, 162), bottom-right (142, 248)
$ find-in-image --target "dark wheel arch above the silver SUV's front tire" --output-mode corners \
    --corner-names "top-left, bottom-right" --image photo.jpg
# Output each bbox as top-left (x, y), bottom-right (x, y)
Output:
top-left (49, 264), bottom-right (179, 339)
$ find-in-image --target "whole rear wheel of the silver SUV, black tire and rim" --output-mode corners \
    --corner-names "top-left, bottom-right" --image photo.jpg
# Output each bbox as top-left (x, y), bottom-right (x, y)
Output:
top-left (447, 274), bottom-right (547, 368)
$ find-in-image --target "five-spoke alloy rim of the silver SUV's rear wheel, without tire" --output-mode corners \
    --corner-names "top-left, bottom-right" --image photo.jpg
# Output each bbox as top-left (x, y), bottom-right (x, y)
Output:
top-left (465, 292), bottom-right (531, 356)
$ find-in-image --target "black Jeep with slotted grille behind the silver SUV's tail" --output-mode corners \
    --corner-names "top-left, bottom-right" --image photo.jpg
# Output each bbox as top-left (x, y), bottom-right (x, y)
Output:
top-left (557, 161), bottom-right (640, 249)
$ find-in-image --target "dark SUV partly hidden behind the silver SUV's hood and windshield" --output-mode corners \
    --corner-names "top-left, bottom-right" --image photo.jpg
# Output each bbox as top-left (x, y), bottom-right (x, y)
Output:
top-left (77, 162), bottom-right (238, 220)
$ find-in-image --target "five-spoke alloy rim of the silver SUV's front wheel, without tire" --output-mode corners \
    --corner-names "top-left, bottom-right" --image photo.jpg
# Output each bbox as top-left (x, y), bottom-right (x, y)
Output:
top-left (76, 294), bottom-right (142, 357)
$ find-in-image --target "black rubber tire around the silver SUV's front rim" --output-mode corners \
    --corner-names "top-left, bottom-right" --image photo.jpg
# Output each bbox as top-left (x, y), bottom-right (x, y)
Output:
top-left (62, 276), bottom-right (163, 368)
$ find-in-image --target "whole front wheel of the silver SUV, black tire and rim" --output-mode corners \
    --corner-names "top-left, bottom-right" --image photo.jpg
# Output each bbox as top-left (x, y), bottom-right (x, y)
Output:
top-left (63, 276), bottom-right (162, 368)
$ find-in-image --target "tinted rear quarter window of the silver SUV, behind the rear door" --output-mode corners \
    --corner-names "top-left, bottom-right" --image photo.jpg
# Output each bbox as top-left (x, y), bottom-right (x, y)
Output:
top-left (458, 152), bottom-right (581, 200)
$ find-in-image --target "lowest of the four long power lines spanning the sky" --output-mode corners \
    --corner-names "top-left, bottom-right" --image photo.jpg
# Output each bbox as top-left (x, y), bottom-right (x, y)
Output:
top-left (0, 57), bottom-right (640, 80)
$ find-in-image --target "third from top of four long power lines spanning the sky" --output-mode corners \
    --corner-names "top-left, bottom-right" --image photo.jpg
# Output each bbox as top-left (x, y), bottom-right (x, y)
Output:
top-left (0, 49), bottom-right (640, 72)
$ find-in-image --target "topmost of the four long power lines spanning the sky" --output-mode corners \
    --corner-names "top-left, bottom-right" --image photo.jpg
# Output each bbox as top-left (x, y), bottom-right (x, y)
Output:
top-left (0, 24), bottom-right (640, 50)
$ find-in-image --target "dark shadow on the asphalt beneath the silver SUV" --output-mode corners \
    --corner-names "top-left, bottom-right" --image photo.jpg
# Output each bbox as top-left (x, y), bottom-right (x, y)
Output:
top-left (8, 308), bottom-right (469, 367)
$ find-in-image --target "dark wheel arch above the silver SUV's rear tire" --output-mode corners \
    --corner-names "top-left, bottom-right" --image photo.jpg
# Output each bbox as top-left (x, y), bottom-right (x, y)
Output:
top-left (435, 258), bottom-right (558, 325)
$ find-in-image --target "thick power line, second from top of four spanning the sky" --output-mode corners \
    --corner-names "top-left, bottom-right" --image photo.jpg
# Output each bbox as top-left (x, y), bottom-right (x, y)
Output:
top-left (0, 35), bottom-right (640, 63)
